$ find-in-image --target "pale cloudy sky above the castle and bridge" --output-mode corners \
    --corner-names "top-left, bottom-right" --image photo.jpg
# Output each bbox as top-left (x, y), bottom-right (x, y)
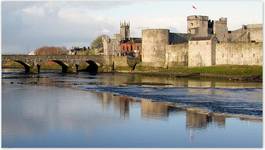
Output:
top-left (1, 0), bottom-right (263, 54)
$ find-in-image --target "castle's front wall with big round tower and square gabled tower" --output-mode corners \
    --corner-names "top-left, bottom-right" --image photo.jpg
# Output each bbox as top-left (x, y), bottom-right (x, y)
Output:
top-left (142, 29), bottom-right (263, 67)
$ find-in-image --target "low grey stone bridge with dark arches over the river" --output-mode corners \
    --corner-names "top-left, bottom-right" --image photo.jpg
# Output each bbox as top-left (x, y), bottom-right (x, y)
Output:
top-left (2, 55), bottom-right (128, 73)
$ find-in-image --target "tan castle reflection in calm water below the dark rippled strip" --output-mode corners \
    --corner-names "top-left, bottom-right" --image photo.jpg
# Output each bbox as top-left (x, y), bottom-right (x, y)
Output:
top-left (97, 93), bottom-right (261, 129)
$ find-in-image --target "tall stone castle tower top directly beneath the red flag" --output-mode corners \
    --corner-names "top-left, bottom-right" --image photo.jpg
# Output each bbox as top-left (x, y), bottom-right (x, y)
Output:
top-left (187, 15), bottom-right (208, 37)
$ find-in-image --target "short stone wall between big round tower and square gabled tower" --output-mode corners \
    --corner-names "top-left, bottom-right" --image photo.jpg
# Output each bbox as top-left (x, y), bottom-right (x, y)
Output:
top-left (165, 43), bottom-right (188, 67)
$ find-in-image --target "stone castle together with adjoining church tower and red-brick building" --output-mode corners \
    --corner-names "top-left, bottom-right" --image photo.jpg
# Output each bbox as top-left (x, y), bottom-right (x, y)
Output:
top-left (102, 15), bottom-right (263, 67)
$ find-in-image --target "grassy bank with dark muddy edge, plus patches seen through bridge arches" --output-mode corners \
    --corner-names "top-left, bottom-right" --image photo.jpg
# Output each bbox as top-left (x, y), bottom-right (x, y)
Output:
top-left (2, 62), bottom-right (262, 82)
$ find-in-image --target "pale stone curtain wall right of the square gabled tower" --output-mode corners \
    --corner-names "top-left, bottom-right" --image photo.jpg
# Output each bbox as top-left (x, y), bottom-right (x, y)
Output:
top-left (216, 42), bottom-right (263, 65)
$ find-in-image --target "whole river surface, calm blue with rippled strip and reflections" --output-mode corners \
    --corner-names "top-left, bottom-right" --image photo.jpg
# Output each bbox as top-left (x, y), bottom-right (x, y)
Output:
top-left (2, 69), bottom-right (262, 147)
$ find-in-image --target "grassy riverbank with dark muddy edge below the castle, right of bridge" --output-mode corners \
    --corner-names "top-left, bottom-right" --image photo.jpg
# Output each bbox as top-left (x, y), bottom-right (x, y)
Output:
top-left (112, 65), bottom-right (262, 82)
